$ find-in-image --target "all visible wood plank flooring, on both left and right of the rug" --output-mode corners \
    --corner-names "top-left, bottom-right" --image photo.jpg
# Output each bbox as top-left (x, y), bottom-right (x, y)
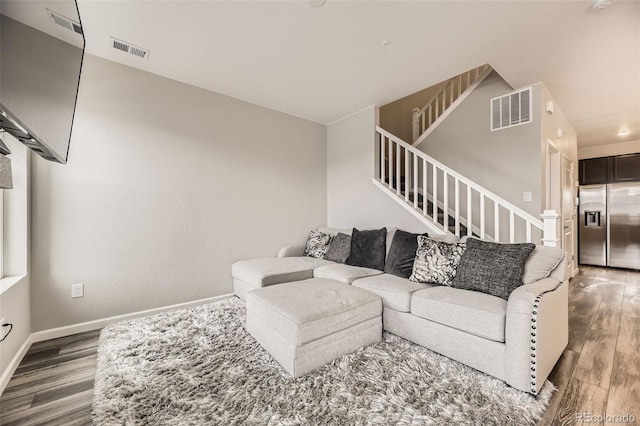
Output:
top-left (0, 267), bottom-right (640, 426)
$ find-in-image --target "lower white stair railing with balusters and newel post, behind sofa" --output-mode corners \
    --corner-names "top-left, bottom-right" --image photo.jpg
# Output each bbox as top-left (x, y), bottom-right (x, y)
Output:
top-left (373, 127), bottom-right (559, 247)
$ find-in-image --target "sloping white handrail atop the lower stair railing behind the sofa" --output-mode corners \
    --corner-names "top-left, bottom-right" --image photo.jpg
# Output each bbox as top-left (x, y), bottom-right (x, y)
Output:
top-left (376, 126), bottom-right (545, 231)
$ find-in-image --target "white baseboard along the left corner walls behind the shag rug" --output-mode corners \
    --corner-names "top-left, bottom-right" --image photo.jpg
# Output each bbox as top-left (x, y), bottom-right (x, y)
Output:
top-left (0, 293), bottom-right (233, 395)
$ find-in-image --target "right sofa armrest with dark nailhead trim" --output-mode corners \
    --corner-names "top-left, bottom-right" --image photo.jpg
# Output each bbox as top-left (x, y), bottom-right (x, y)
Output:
top-left (504, 278), bottom-right (569, 395)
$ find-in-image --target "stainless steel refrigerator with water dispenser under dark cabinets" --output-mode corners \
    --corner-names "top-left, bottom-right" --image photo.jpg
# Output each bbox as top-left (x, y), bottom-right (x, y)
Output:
top-left (579, 182), bottom-right (640, 269)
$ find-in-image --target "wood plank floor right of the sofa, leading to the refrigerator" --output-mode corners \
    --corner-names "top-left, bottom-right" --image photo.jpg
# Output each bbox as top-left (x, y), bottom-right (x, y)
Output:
top-left (540, 267), bottom-right (640, 425)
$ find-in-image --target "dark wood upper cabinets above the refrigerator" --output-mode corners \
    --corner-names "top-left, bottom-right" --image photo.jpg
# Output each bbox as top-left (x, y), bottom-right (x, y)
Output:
top-left (579, 153), bottom-right (640, 185)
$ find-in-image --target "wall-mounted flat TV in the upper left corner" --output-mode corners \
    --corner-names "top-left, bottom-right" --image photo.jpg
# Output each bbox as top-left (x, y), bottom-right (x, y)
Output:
top-left (0, 0), bottom-right (85, 163)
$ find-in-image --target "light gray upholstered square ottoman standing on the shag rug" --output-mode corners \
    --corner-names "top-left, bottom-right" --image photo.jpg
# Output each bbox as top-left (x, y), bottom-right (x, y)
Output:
top-left (246, 278), bottom-right (382, 377)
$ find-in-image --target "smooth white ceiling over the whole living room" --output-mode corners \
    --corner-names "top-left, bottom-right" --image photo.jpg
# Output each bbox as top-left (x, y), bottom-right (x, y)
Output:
top-left (52, 0), bottom-right (640, 147)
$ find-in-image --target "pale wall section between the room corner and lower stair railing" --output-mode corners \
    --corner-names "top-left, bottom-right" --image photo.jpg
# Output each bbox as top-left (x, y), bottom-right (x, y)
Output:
top-left (327, 106), bottom-right (427, 232)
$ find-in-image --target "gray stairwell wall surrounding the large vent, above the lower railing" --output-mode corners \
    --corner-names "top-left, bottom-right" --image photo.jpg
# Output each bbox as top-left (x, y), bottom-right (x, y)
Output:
top-left (419, 71), bottom-right (542, 217)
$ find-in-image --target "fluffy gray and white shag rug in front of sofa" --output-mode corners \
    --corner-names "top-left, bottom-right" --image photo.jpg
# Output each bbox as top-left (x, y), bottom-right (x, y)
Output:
top-left (93, 298), bottom-right (554, 426)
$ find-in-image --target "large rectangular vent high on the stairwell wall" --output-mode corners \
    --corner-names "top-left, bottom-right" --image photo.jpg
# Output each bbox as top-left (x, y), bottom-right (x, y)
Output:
top-left (490, 87), bottom-right (533, 131)
